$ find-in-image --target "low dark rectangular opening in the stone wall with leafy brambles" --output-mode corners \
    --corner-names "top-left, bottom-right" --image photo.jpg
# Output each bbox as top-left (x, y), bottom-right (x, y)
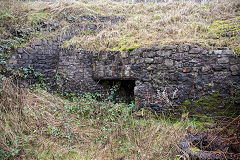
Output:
top-left (99, 80), bottom-right (135, 104)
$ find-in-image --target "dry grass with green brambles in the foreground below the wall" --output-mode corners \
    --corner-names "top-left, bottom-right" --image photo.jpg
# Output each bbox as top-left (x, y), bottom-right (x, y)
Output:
top-left (0, 77), bottom-right (207, 159)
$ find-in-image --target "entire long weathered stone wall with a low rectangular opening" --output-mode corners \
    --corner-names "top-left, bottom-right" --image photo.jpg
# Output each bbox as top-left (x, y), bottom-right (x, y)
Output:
top-left (8, 38), bottom-right (240, 112)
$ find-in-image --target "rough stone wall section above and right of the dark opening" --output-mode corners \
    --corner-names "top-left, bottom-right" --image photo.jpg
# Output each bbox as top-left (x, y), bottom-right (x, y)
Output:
top-left (93, 45), bottom-right (240, 112)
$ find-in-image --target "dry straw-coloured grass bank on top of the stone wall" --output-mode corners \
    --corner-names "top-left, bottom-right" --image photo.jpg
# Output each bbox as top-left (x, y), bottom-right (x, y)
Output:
top-left (0, 0), bottom-right (240, 53)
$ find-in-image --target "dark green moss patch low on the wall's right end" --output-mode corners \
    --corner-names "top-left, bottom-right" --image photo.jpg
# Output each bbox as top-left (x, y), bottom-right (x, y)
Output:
top-left (180, 90), bottom-right (240, 123)
